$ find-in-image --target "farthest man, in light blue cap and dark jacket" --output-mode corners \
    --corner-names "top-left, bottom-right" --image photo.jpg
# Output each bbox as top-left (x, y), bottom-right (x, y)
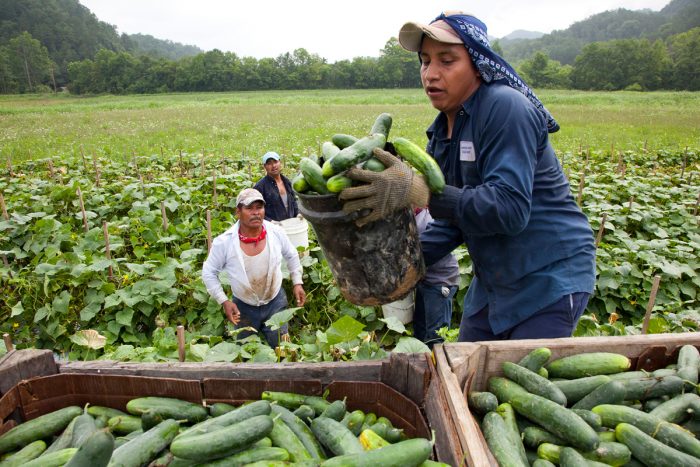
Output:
top-left (254, 151), bottom-right (299, 222)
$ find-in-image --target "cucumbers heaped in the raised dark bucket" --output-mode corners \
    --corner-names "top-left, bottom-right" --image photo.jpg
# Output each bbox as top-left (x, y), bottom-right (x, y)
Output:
top-left (292, 113), bottom-right (445, 195)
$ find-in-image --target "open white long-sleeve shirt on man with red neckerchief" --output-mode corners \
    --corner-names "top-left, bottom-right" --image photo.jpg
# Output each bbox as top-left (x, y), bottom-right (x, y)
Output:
top-left (202, 221), bottom-right (302, 306)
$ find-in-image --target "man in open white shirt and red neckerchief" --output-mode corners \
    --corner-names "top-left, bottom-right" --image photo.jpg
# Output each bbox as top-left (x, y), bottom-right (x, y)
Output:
top-left (202, 188), bottom-right (306, 347)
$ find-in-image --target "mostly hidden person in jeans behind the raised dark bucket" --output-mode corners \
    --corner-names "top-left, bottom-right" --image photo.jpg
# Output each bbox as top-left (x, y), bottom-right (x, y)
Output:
top-left (413, 208), bottom-right (459, 348)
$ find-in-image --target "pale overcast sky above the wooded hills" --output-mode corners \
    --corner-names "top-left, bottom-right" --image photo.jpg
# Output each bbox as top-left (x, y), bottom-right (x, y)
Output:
top-left (80, 0), bottom-right (671, 62)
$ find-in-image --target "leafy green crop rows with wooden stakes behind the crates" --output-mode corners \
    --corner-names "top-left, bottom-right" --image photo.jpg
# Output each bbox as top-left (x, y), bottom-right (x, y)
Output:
top-left (0, 149), bottom-right (700, 361)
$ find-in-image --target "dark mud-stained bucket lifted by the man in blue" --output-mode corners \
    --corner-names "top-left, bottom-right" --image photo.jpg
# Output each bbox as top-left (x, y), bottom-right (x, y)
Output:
top-left (297, 193), bottom-right (425, 305)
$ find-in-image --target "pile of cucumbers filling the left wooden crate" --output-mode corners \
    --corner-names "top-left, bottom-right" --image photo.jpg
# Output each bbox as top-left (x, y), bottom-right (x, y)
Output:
top-left (0, 391), bottom-right (446, 467)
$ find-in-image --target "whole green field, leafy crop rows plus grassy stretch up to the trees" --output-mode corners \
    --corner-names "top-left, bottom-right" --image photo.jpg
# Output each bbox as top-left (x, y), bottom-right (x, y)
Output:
top-left (0, 89), bottom-right (700, 362)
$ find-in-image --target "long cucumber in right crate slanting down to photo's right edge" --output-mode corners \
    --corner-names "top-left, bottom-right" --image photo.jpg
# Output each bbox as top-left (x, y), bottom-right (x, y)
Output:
top-left (593, 404), bottom-right (700, 458)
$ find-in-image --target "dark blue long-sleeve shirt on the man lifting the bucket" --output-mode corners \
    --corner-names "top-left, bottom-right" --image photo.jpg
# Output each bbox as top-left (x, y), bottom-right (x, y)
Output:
top-left (421, 83), bottom-right (595, 334)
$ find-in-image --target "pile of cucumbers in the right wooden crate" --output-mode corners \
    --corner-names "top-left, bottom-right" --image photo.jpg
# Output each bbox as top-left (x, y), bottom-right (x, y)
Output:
top-left (467, 345), bottom-right (700, 467)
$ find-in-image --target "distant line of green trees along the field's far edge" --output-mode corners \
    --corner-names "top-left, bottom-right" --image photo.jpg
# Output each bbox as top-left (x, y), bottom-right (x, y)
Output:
top-left (0, 28), bottom-right (700, 94)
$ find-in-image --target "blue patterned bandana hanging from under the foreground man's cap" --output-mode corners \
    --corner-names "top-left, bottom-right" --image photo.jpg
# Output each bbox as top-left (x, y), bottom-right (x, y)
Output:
top-left (432, 13), bottom-right (559, 133)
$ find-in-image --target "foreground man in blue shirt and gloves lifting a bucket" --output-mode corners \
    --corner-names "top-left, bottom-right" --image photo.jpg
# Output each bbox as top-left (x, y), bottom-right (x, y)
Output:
top-left (340, 12), bottom-right (595, 341)
